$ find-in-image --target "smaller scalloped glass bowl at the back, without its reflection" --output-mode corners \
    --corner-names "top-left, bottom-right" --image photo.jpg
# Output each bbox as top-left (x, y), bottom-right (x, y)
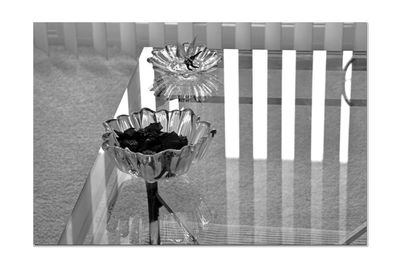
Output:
top-left (147, 43), bottom-right (222, 77)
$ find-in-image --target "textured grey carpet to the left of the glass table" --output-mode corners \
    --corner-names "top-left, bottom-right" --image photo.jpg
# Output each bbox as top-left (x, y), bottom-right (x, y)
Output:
top-left (34, 47), bottom-right (136, 245)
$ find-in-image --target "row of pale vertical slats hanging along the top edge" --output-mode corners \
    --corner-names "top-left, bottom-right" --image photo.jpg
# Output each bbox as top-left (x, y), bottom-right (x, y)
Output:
top-left (34, 23), bottom-right (367, 57)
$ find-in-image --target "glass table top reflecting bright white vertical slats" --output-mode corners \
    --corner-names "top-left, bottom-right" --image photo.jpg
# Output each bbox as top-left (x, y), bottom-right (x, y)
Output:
top-left (60, 48), bottom-right (367, 245)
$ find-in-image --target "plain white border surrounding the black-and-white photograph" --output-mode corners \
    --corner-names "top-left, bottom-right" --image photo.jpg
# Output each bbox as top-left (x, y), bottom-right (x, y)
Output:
top-left (0, 0), bottom-right (400, 266)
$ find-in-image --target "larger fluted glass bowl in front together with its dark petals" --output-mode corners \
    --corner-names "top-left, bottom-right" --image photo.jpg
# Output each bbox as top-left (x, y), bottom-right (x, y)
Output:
top-left (102, 108), bottom-right (216, 182)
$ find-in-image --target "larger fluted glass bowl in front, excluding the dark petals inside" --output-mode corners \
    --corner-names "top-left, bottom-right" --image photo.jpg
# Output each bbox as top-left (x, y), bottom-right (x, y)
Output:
top-left (102, 108), bottom-right (216, 183)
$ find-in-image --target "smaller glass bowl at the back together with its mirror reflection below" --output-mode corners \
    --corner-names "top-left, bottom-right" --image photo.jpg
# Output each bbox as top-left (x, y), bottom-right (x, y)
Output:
top-left (147, 38), bottom-right (222, 102)
